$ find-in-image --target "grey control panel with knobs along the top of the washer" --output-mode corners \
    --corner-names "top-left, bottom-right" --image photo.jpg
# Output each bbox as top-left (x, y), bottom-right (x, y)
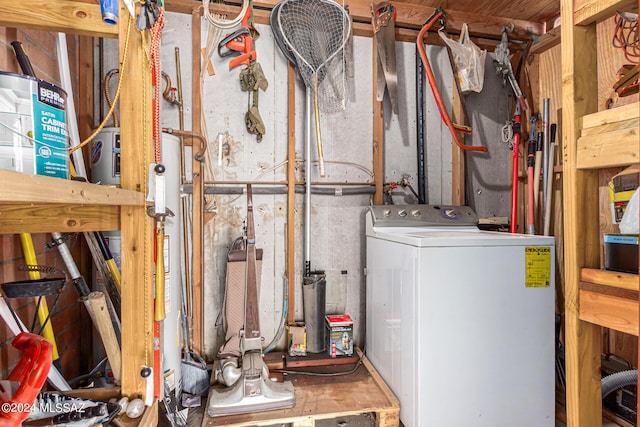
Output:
top-left (369, 205), bottom-right (478, 227)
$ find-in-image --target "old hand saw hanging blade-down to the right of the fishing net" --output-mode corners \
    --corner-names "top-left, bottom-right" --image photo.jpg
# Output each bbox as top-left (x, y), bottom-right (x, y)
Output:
top-left (371, 0), bottom-right (398, 114)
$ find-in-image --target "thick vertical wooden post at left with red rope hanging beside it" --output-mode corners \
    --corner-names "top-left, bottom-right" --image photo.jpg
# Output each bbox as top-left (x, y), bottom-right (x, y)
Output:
top-left (118, 3), bottom-right (153, 399)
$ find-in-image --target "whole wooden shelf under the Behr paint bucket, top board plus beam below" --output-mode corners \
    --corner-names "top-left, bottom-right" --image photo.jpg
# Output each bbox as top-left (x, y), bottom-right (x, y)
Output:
top-left (0, 170), bottom-right (144, 234)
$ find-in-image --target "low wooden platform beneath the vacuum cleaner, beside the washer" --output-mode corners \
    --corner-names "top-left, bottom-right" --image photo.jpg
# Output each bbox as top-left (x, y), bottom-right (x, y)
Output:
top-left (202, 357), bottom-right (400, 427)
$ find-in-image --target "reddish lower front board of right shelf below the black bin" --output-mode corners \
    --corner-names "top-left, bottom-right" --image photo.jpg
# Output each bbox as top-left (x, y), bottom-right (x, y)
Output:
top-left (579, 283), bottom-right (638, 336)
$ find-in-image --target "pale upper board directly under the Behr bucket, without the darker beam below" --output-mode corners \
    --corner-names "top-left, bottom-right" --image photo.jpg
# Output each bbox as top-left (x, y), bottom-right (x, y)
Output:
top-left (0, 172), bottom-right (144, 206)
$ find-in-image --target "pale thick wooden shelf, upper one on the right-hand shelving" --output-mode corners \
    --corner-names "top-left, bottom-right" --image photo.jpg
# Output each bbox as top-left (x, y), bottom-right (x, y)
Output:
top-left (576, 102), bottom-right (640, 169)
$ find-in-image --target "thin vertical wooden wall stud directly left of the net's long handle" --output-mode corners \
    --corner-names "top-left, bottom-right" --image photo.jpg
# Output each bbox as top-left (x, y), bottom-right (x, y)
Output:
top-left (286, 62), bottom-right (296, 323)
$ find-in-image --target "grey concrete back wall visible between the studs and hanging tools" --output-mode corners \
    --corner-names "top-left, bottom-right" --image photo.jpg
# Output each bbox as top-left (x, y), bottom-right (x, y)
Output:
top-left (104, 13), bottom-right (464, 357)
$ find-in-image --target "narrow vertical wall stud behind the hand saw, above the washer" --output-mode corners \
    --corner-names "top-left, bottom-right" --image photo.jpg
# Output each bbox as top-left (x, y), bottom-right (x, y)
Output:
top-left (371, 37), bottom-right (384, 205)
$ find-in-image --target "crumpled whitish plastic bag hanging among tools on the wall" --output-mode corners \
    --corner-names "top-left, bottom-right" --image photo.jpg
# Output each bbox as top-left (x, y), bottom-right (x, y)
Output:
top-left (438, 23), bottom-right (487, 94)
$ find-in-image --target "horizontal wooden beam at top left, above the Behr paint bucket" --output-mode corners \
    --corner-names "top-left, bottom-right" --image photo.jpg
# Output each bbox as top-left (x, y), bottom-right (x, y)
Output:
top-left (0, 0), bottom-right (117, 38)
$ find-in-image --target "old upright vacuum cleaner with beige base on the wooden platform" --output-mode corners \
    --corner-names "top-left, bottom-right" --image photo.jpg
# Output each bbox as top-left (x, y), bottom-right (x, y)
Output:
top-left (208, 185), bottom-right (295, 417)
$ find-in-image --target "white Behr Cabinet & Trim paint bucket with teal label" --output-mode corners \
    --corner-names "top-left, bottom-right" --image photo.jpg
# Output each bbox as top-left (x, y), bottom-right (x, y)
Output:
top-left (0, 71), bottom-right (69, 179)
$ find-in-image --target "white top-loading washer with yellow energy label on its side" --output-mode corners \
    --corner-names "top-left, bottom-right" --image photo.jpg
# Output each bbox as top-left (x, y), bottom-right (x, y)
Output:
top-left (365, 205), bottom-right (555, 427)
